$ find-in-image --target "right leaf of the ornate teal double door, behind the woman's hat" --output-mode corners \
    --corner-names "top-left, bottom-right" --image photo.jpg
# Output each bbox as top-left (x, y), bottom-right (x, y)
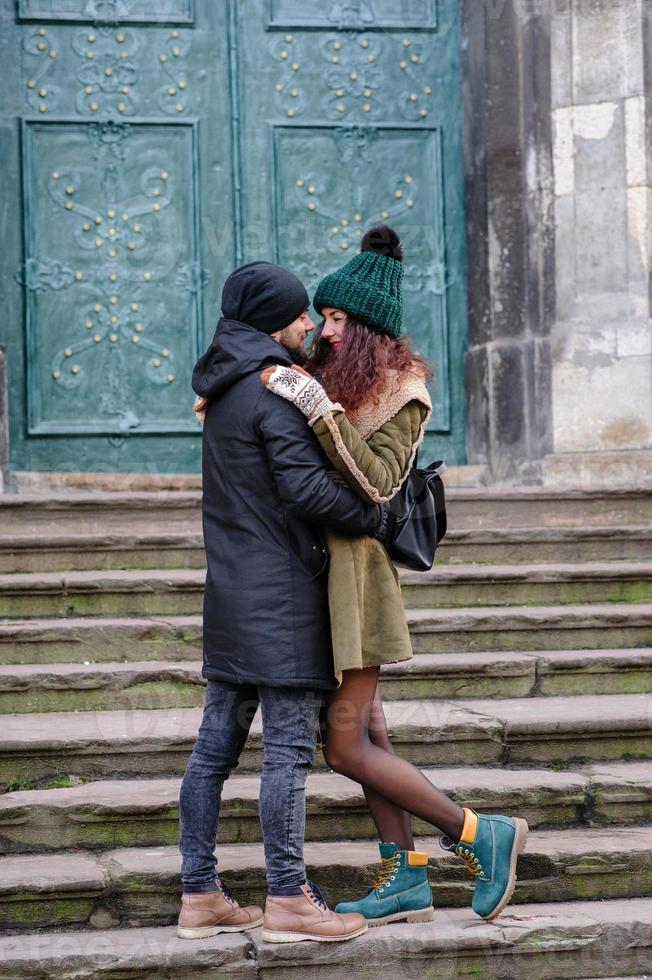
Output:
top-left (238, 0), bottom-right (466, 463)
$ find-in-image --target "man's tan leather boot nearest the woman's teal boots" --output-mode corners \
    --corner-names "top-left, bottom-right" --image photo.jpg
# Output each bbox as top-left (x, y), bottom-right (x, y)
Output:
top-left (263, 882), bottom-right (367, 943)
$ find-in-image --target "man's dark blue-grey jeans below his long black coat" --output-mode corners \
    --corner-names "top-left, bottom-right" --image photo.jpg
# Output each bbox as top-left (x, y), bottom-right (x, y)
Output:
top-left (179, 680), bottom-right (323, 894)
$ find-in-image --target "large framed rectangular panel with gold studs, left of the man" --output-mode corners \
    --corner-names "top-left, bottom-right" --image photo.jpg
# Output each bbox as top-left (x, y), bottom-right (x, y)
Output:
top-left (24, 122), bottom-right (200, 434)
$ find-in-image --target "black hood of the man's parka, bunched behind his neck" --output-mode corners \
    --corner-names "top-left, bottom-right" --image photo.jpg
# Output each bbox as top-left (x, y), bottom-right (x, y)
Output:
top-left (192, 317), bottom-right (293, 401)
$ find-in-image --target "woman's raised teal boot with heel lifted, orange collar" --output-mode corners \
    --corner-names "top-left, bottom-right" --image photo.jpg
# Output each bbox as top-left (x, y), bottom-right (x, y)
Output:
top-left (440, 807), bottom-right (528, 919)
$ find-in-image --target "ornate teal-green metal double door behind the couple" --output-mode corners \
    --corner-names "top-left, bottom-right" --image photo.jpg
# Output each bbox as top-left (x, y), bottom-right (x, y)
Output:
top-left (0, 0), bottom-right (466, 473)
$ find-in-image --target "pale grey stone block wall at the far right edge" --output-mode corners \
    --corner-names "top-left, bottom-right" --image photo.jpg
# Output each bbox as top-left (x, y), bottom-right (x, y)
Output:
top-left (544, 0), bottom-right (652, 482)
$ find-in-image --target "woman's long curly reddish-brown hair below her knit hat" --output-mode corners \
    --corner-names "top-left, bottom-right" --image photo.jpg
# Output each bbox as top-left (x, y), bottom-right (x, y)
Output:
top-left (306, 318), bottom-right (433, 411)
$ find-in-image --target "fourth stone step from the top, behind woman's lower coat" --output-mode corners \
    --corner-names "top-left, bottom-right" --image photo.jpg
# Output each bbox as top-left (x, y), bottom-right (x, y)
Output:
top-left (0, 603), bottom-right (652, 664)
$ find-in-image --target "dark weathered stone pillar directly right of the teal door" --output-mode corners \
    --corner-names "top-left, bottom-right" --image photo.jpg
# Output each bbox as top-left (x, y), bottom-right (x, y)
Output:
top-left (461, 0), bottom-right (555, 484)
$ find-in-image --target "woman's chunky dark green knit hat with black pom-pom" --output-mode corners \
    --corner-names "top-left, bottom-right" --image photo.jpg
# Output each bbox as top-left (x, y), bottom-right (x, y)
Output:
top-left (312, 225), bottom-right (403, 337)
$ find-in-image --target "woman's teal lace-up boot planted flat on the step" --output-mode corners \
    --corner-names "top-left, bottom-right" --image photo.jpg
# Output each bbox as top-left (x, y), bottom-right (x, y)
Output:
top-left (335, 844), bottom-right (435, 926)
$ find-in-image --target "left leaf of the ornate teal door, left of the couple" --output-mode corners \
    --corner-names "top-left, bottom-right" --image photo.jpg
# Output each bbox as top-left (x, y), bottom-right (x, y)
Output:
top-left (0, 0), bottom-right (234, 473)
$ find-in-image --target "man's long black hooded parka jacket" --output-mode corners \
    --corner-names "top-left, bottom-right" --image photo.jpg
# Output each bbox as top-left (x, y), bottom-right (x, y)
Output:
top-left (193, 319), bottom-right (379, 689)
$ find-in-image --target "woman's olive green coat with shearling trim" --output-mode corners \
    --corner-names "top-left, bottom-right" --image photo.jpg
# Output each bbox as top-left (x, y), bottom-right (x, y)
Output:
top-left (313, 385), bottom-right (431, 682)
